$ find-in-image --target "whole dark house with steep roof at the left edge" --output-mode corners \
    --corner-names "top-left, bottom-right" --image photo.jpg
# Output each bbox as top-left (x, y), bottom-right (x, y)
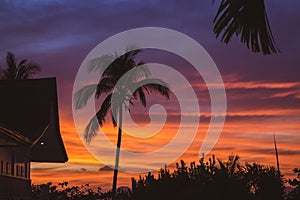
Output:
top-left (0, 78), bottom-right (68, 199)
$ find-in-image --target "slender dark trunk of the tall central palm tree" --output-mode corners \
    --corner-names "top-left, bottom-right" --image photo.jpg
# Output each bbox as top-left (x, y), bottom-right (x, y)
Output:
top-left (112, 104), bottom-right (122, 200)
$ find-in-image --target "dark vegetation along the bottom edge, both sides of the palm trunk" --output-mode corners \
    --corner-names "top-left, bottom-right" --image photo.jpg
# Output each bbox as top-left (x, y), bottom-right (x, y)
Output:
top-left (32, 156), bottom-right (300, 200)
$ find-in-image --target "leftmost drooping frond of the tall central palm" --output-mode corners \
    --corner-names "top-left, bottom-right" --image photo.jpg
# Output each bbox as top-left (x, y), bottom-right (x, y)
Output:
top-left (73, 84), bottom-right (97, 110)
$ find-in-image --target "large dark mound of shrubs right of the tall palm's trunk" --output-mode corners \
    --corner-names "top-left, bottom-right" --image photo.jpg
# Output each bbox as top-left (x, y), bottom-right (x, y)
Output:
top-left (132, 155), bottom-right (284, 200)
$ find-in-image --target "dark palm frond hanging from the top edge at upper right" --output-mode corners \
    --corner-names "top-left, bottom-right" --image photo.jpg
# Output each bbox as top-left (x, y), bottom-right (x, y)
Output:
top-left (213, 0), bottom-right (280, 54)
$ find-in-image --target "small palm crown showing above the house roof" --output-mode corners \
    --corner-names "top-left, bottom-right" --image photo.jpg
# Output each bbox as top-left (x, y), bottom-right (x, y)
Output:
top-left (0, 52), bottom-right (41, 80)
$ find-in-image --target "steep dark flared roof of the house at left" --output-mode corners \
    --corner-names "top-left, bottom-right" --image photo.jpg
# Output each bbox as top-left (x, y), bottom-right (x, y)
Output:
top-left (0, 78), bottom-right (68, 162)
